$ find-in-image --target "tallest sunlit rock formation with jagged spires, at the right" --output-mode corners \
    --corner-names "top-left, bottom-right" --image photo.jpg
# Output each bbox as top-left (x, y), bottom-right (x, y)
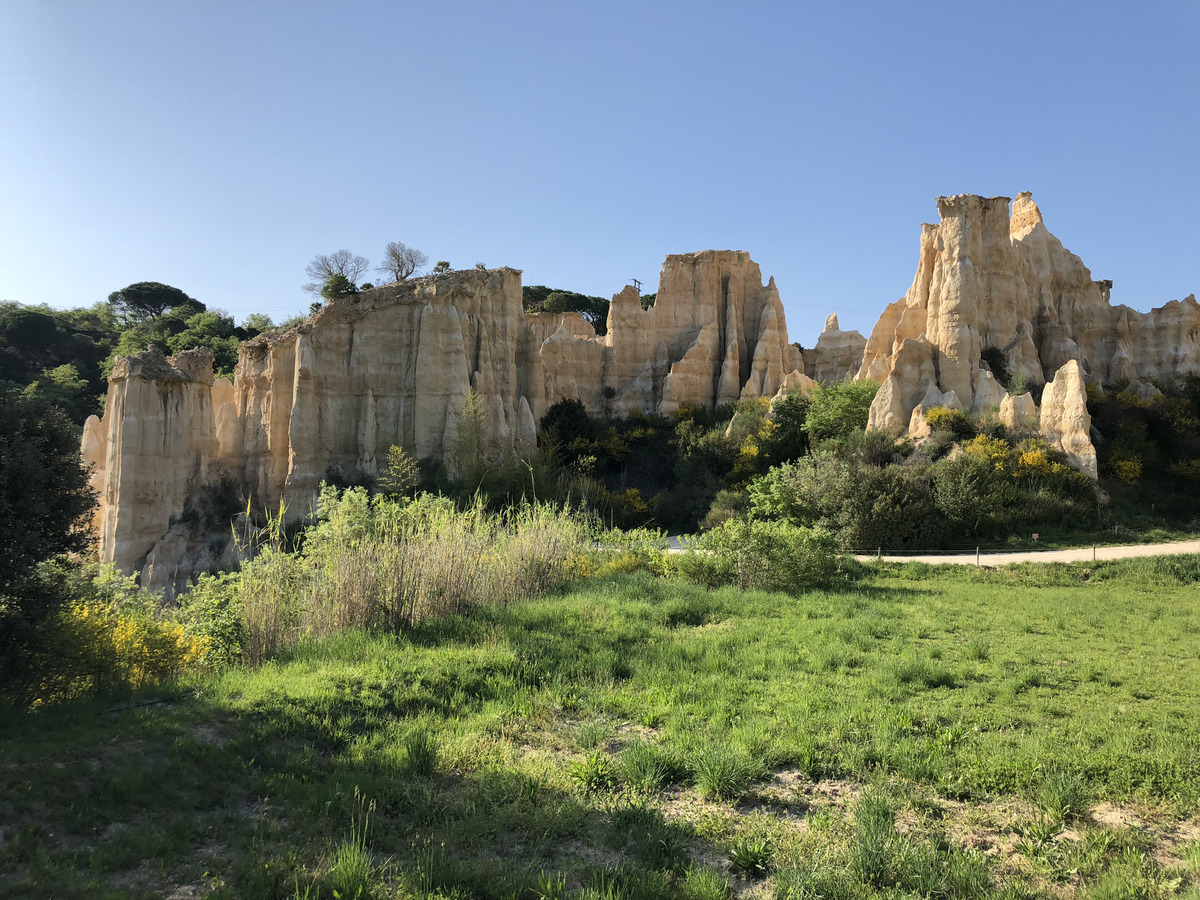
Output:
top-left (857, 193), bottom-right (1200, 441)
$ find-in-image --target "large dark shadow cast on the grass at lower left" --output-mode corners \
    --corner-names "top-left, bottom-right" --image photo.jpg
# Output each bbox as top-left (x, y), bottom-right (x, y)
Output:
top-left (0, 657), bottom-right (698, 899)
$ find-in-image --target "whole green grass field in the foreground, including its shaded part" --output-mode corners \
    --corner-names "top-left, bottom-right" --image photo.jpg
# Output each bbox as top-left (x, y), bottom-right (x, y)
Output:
top-left (0, 558), bottom-right (1200, 900)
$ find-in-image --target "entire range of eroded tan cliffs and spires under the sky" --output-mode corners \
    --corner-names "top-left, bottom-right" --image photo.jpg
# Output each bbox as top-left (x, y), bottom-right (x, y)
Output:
top-left (83, 193), bottom-right (1200, 582)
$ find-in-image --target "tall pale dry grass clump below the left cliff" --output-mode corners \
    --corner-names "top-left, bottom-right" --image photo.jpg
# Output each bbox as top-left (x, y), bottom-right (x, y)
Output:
top-left (235, 488), bottom-right (589, 664)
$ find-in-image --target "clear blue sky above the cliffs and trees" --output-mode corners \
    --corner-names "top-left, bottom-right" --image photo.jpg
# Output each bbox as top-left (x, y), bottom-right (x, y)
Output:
top-left (0, 0), bottom-right (1200, 346)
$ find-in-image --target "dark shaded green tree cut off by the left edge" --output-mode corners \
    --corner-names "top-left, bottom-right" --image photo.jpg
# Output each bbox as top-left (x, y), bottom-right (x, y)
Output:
top-left (0, 389), bottom-right (95, 690)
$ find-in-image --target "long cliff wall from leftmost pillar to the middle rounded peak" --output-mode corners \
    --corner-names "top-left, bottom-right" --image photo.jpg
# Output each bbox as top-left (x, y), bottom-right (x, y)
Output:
top-left (91, 251), bottom-right (803, 573)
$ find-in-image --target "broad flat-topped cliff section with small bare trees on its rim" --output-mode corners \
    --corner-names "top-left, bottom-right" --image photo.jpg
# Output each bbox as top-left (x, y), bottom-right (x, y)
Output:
top-left (227, 269), bottom-right (532, 515)
